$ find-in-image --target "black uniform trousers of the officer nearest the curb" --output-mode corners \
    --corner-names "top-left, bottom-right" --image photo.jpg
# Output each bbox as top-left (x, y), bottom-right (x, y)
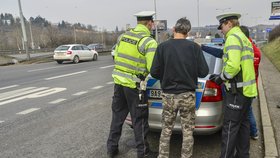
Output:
top-left (220, 91), bottom-right (253, 158)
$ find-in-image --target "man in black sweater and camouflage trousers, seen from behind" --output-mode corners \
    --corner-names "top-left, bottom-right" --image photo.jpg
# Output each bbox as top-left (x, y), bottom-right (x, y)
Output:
top-left (150, 18), bottom-right (209, 158)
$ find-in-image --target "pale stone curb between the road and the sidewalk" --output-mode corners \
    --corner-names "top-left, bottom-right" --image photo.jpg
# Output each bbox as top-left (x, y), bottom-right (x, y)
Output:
top-left (258, 74), bottom-right (279, 158)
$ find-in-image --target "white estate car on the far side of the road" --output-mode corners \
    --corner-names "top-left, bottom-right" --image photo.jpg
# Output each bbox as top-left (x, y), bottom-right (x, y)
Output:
top-left (53, 44), bottom-right (98, 64)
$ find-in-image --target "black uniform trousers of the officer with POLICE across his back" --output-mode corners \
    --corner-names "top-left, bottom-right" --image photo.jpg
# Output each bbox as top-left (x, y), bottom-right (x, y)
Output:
top-left (107, 84), bottom-right (149, 158)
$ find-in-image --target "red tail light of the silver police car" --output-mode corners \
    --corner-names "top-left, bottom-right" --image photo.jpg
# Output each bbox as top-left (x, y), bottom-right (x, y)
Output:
top-left (201, 80), bottom-right (223, 102)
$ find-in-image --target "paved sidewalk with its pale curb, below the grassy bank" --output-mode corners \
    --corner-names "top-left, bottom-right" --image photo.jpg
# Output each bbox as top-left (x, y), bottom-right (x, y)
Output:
top-left (259, 54), bottom-right (280, 158)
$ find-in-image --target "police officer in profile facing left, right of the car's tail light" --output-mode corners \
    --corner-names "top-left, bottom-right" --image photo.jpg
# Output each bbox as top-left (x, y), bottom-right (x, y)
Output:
top-left (210, 13), bottom-right (257, 158)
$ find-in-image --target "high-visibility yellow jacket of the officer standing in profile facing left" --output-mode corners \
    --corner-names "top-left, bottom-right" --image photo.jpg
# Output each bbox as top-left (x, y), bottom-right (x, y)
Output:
top-left (221, 27), bottom-right (257, 97)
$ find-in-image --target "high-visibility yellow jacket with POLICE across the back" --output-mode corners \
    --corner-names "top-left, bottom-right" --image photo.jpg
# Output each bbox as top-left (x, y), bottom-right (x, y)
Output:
top-left (112, 24), bottom-right (157, 88)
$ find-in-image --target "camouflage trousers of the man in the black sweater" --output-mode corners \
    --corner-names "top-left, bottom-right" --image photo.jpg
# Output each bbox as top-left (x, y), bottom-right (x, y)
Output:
top-left (158, 92), bottom-right (195, 158)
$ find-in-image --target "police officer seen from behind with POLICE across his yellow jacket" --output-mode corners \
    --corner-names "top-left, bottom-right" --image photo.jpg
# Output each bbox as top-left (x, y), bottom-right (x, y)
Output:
top-left (107, 11), bottom-right (157, 158)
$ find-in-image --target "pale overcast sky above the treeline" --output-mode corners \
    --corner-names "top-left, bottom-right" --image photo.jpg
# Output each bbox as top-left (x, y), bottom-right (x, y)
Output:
top-left (0, 0), bottom-right (280, 30)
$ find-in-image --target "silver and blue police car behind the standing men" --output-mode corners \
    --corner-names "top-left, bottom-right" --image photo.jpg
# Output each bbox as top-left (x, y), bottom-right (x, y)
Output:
top-left (126, 45), bottom-right (223, 135)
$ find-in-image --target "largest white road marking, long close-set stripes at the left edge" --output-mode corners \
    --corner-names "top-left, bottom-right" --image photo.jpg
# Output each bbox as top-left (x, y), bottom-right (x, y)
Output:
top-left (0, 87), bottom-right (66, 105)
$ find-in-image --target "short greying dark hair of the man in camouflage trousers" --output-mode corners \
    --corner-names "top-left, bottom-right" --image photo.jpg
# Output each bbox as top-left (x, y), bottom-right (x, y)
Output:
top-left (174, 17), bottom-right (192, 35)
